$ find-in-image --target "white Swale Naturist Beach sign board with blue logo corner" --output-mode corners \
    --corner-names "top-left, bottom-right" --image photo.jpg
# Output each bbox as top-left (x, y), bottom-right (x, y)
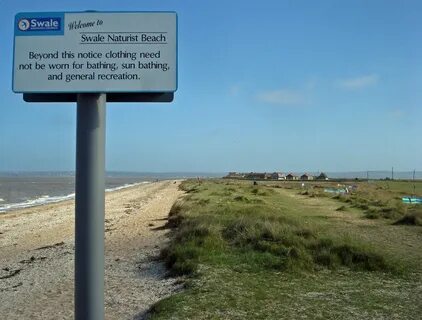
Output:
top-left (13, 12), bottom-right (177, 93)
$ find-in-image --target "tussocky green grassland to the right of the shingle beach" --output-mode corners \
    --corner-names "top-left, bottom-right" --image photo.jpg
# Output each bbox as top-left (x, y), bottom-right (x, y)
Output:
top-left (149, 180), bottom-right (422, 319)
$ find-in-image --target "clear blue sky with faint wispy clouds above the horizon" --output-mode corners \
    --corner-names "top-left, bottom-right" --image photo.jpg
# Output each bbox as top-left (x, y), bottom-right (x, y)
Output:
top-left (0, 0), bottom-right (422, 172)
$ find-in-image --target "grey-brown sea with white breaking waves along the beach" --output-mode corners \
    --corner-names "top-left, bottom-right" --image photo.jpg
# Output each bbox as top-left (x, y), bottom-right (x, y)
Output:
top-left (0, 172), bottom-right (224, 214)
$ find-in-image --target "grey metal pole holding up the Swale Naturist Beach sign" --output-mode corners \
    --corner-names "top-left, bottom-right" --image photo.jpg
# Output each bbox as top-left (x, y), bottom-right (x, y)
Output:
top-left (75, 94), bottom-right (106, 320)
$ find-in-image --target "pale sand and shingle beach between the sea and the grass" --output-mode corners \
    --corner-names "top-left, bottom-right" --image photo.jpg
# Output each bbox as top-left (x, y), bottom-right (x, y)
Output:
top-left (0, 181), bottom-right (181, 320)
